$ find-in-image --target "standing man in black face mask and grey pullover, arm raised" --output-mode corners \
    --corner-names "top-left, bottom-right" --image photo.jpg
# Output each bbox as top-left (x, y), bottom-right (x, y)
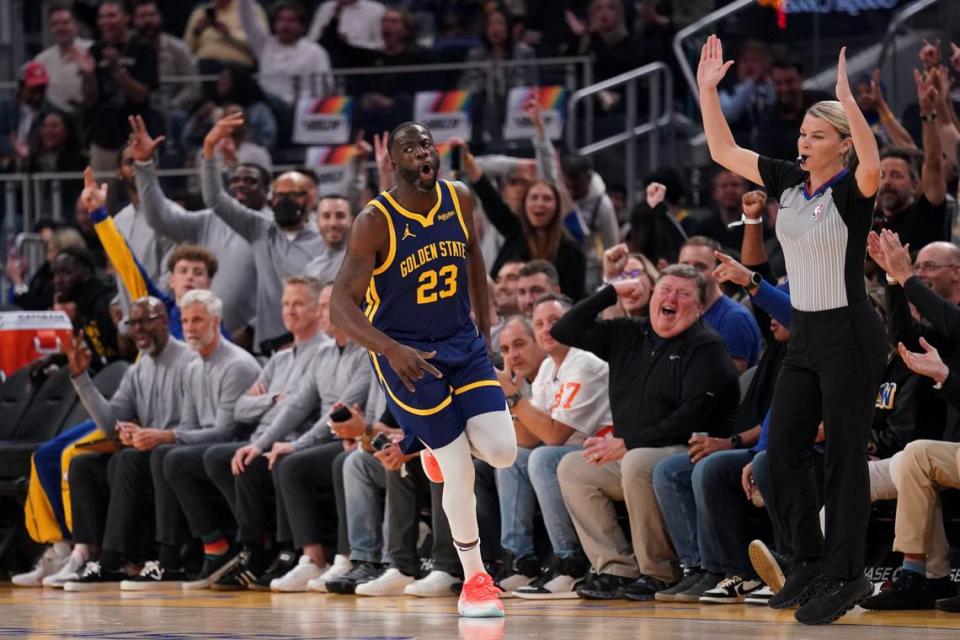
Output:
top-left (201, 114), bottom-right (328, 355)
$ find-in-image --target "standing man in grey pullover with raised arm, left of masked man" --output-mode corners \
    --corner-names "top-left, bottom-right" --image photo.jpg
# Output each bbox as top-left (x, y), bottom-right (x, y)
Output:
top-left (130, 116), bottom-right (262, 344)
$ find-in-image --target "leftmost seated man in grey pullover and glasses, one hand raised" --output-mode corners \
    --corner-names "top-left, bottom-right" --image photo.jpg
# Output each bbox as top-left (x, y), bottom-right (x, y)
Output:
top-left (56, 297), bottom-right (196, 591)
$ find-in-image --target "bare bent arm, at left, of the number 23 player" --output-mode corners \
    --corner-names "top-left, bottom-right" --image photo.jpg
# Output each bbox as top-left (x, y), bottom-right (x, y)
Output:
top-left (330, 207), bottom-right (441, 391)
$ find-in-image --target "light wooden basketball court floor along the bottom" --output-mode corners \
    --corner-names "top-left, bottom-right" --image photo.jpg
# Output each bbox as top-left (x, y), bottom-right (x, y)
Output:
top-left (0, 585), bottom-right (960, 640)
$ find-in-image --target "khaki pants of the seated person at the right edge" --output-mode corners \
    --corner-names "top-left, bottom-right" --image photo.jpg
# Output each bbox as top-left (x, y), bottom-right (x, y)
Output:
top-left (893, 440), bottom-right (960, 577)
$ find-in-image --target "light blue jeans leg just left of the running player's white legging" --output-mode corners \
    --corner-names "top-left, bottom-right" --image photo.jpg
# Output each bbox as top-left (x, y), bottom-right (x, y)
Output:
top-left (343, 449), bottom-right (388, 562)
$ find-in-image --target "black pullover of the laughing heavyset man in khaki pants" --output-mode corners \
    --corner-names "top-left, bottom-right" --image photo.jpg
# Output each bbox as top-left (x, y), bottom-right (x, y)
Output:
top-left (550, 287), bottom-right (740, 449)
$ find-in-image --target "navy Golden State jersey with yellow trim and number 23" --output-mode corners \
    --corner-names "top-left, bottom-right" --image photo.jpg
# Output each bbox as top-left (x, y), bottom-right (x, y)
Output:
top-left (365, 180), bottom-right (476, 342)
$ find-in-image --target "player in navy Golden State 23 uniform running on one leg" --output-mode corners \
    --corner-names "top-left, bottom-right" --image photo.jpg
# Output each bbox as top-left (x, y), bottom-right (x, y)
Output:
top-left (330, 122), bottom-right (517, 617)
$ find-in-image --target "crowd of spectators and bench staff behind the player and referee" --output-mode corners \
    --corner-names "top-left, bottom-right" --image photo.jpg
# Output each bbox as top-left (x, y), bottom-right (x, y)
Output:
top-left (0, 0), bottom-right (960, 624)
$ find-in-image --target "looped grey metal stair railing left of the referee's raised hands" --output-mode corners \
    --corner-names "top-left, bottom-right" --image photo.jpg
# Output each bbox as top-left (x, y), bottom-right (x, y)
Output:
top-left (566, 62), bottom-right (674, 207)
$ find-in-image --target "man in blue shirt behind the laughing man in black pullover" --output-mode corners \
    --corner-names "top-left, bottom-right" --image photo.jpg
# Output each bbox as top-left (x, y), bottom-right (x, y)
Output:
top-left (679, 236), bottom-right (763, 373)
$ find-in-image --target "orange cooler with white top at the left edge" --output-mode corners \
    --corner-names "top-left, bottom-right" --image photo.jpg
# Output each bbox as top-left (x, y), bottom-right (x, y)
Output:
top-left (0, 311), bottom-right (73, 376)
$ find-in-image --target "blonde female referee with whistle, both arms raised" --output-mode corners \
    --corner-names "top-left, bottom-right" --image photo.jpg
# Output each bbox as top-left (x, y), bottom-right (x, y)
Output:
top-left (697, 35), bottom-right (887, 624)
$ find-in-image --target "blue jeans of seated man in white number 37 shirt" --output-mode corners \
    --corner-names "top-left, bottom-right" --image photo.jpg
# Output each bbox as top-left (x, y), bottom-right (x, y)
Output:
top-left (497, 445), bottom-right (581, 558)
